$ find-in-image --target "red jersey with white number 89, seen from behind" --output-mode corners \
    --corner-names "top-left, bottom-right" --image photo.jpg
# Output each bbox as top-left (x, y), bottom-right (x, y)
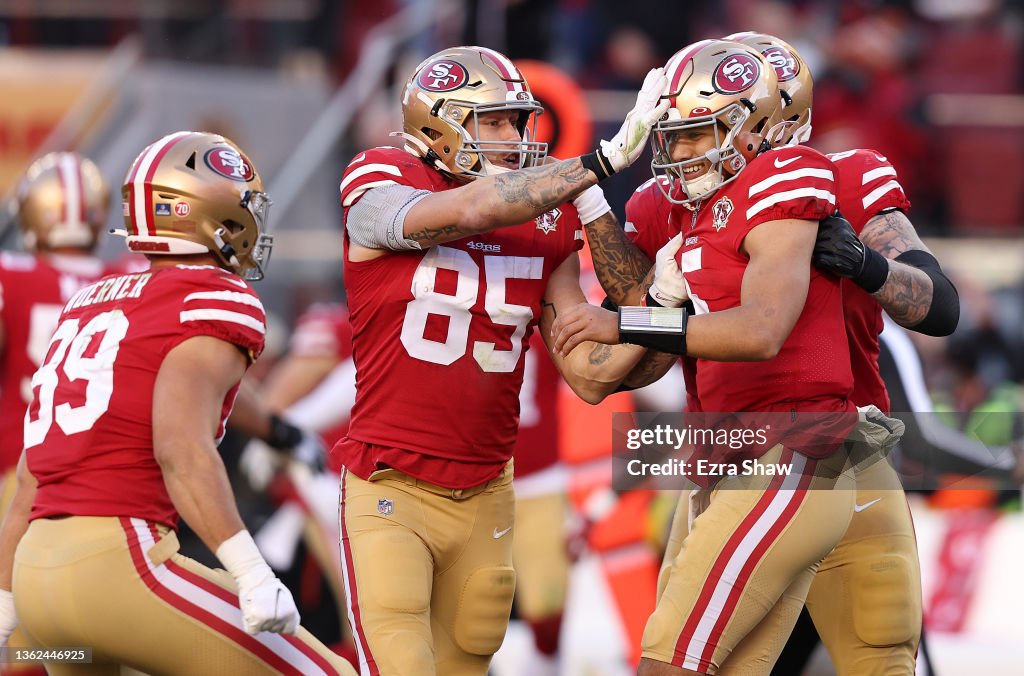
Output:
top-left (25, 265), bottom-right (266, 527)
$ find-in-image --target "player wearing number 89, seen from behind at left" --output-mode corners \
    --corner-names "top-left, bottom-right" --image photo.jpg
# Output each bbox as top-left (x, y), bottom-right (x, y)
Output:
top-left (0, 131), bottom-right (353, 674)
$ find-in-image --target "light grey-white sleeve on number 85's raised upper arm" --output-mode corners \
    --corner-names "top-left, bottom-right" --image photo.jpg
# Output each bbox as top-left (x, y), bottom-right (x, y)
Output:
top-left (345, 185), bottom-right (430, 251)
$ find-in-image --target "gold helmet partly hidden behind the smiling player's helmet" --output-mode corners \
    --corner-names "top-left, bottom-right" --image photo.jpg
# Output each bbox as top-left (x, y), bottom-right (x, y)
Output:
top-left (725, 32), bottom-right (814, 145)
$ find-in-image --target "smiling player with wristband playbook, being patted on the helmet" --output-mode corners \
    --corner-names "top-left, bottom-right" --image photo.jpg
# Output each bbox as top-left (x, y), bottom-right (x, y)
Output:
top-left (556, 41), bottom-right (913, 675)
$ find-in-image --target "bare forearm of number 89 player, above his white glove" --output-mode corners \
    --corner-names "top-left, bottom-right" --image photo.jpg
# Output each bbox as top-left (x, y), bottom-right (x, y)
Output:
top-left (157, 440), bottom-right (245, 552)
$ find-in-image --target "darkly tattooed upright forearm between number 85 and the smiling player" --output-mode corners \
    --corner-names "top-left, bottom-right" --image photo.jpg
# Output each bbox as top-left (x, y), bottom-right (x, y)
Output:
top-left (585, 211), bottom-right (653, 305)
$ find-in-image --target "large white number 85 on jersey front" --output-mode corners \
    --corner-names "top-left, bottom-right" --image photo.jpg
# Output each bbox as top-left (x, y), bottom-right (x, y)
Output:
top-left (401, 246), bottom-right (544, 373)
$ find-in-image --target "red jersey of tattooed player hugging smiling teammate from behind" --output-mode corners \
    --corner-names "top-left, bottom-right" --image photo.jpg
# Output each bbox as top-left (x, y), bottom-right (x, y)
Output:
top-left (828, 150), bottom-right (910, 413)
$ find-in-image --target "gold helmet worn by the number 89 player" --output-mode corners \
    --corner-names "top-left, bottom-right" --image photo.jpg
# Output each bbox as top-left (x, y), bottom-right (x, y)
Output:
top-left (117, 131), bottom-right (273, 281)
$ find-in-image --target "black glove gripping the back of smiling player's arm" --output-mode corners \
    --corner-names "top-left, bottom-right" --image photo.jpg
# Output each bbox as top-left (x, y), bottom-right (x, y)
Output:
top-left (811, 211), bottom-right (889, 293)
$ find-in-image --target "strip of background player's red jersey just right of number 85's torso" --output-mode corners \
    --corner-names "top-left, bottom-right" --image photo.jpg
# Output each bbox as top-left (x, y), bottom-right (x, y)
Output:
top-left (514, 333), bottom-right (562, 479)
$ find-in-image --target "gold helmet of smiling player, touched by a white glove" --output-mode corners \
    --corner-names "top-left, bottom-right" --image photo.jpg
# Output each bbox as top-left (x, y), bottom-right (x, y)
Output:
top-left (651, 40), bottom-right (782, 204)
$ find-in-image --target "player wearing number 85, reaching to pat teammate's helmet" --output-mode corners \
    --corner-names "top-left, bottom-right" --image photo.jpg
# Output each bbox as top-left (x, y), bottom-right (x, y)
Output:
top-left (333, 47), bottom-right (667, 674)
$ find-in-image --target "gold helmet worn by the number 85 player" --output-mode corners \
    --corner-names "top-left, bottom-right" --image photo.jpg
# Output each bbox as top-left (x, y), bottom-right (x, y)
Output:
top-left (396, 47), bottom-right (548, 178)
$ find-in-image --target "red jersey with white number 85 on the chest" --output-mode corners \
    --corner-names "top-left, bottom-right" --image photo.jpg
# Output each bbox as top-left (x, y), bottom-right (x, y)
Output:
top-left (334, 147), bottom-right (583, 489)
